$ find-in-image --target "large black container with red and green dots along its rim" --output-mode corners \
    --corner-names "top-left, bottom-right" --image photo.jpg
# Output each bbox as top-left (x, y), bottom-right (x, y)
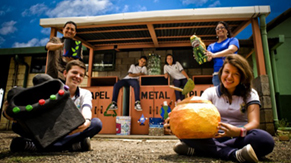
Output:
top-left (6, 79), bottom-right (85, 148)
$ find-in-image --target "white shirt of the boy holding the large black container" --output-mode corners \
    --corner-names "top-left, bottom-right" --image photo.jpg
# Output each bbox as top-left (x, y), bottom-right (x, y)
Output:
top-left (71, 87), bottom-right (92, 112)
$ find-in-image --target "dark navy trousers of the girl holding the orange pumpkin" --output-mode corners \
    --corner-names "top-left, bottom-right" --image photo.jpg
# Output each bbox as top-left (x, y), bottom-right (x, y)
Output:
top-left (181, 129), bottom-right (275, 160)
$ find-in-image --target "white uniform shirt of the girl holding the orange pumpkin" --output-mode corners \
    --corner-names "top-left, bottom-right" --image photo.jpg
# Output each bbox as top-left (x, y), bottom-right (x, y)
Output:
top-left (201, 86), bottom-right (261, 127)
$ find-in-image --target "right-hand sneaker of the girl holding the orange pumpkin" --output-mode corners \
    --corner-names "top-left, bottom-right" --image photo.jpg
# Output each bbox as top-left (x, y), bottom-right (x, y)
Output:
top-left (235, 144), bottom-right (259, 162)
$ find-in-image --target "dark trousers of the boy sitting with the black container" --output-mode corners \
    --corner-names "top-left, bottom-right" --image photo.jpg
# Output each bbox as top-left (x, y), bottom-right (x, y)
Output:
top-left (12, 118), bottom-right (102, 151)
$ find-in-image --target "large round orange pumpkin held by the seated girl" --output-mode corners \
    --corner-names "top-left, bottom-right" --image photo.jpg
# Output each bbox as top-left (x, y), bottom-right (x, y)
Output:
top-left (170, 96), bottom-right (220, 139)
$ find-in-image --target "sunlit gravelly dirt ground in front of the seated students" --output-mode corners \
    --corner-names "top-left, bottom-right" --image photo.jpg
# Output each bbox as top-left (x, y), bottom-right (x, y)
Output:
top-left (0, 131), bottom-right (291, 163)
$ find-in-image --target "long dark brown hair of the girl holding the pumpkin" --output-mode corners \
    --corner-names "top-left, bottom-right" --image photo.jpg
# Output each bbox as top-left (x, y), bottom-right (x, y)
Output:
top-left (218, 54), bottom-right (253, 103)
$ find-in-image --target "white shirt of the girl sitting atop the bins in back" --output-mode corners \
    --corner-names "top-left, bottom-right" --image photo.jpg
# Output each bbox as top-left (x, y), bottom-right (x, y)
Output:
top-left (164, 61), bottom-right (186, 80)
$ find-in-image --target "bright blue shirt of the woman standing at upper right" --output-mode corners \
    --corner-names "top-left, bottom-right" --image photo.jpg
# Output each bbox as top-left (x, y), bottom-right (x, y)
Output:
top-left (207, 37), bottom-right (239, 72)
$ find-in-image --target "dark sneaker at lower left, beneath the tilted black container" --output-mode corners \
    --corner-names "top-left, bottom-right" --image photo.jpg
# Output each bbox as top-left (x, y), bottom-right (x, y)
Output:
top-left (10, 137), bottom-right (37, 152)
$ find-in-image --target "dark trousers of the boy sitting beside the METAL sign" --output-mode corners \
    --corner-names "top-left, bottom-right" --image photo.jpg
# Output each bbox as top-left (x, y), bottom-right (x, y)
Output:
top-left (112, 79), bottom-right (140, 102)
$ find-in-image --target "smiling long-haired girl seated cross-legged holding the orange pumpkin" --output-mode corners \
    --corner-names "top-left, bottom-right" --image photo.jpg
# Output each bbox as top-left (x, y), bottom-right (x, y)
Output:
top-left (164, 54), bottom-right (274, 162)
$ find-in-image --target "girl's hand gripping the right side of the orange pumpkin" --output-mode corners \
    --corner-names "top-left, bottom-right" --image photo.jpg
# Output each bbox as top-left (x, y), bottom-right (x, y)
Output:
top-left (215, 122), bottom-right (240, 138)
